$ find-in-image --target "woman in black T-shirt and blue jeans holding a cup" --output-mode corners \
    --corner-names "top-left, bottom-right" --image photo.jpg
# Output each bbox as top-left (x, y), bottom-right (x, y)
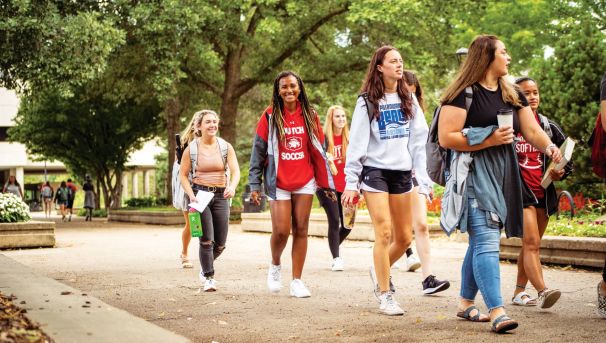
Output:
top-left (438, 35), bottom-right (561, 333)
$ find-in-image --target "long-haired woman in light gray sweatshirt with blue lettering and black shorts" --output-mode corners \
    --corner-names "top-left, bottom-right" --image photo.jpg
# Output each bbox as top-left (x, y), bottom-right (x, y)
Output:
top-left (341, 46), bottom-right (431, 315)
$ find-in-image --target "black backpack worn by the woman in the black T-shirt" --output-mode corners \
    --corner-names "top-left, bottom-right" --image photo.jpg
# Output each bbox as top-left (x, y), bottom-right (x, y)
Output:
top-left (425, 86), bottom-right (473, 186)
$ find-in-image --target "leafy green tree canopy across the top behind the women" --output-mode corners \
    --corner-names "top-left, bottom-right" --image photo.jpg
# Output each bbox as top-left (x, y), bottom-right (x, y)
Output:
top-left (0, 0), bottom-right (606, 200)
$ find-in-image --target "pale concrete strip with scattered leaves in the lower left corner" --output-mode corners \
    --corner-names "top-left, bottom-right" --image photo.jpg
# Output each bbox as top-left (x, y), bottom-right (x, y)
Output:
top-left (0, 254), bottom-right (189, 343)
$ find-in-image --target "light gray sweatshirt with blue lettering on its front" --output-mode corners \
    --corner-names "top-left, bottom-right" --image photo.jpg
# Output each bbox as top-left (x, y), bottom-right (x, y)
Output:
top-left (345, 93), bottom-right (432, 194)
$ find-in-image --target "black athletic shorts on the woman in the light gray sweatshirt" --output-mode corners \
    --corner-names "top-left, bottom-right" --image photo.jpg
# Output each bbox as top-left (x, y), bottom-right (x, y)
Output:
top-left (361, 166), bottom-right (412, 194)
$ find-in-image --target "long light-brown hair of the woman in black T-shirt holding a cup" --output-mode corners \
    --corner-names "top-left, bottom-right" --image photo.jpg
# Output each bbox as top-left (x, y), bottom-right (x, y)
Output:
top-left (440, 35), bottom-right (522, 106)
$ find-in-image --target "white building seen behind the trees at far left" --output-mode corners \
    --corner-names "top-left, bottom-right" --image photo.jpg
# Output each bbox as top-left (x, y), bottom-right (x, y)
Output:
top-left (0, 88), bottom-right (163, 204)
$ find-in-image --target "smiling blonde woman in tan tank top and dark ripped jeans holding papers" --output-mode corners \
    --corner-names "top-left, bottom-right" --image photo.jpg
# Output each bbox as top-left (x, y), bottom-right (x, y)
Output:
top-left (180, 110), bottom-right (240, 292)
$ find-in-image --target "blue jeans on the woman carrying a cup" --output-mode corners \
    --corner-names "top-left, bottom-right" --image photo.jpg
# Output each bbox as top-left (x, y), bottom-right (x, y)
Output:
top-left (460, 198), bottom-right (503, 310)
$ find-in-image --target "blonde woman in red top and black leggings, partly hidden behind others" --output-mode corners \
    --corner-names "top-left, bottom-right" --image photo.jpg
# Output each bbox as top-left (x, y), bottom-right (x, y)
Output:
top-left (316, 106), bottom-right (351, 271)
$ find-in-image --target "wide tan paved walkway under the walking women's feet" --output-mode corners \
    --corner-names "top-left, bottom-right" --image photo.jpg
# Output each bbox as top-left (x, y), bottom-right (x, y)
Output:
top-left (4, 220), bottom-right (606, 342)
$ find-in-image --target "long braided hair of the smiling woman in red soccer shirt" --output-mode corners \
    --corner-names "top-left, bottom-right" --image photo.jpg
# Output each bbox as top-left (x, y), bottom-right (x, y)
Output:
top-left (271, 71), bottom-right (319, 142)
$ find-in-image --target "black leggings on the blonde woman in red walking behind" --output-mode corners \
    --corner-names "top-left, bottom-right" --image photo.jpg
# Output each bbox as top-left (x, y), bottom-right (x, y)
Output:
top-left (316, 189), bottom-right (351, 258)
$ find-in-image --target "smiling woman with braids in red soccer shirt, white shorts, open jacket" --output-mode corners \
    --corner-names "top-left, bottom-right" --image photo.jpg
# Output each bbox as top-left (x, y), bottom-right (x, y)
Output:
top-left (248, 71), bottom-right (336, 298)
